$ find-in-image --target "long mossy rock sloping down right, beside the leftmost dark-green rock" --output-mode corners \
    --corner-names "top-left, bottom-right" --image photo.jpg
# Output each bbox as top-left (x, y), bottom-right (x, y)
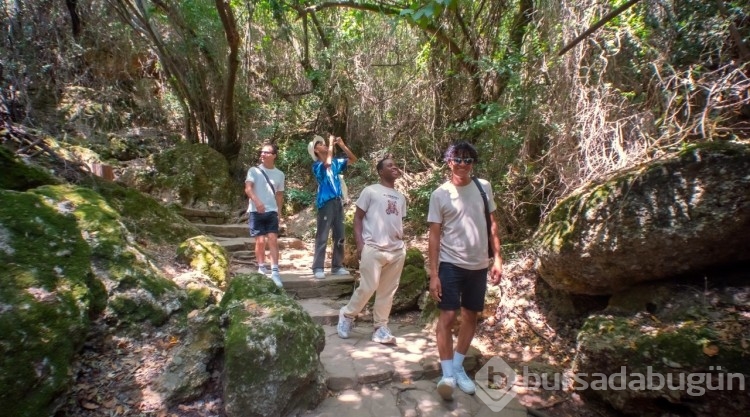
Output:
top-left (31, 186), bottom-right (183, 325)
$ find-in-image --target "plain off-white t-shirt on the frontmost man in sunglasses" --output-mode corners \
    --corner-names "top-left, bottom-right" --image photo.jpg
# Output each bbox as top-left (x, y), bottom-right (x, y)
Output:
top-left (427, 179), bottom-right (496, 270)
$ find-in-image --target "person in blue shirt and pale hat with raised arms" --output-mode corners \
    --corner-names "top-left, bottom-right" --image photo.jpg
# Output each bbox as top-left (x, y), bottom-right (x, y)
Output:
top-left (307, 135), bottom-right (357, 279)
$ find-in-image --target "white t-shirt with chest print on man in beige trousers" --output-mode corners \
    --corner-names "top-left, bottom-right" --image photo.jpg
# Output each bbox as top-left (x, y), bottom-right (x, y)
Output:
top-left (357, 184), bottom-right (406, 251)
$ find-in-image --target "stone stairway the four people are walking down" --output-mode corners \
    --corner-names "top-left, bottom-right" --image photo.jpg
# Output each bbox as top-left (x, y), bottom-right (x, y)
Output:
top-left (194, 214), bottom-right (527, 417)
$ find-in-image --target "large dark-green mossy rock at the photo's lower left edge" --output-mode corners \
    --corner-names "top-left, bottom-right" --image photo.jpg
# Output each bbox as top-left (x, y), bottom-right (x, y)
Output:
top-left (0, 191), bottom-right (97, 417)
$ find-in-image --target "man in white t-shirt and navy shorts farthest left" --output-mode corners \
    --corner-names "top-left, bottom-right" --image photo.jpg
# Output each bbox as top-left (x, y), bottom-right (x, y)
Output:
top-left (245, 144), bottom-right (285, 287)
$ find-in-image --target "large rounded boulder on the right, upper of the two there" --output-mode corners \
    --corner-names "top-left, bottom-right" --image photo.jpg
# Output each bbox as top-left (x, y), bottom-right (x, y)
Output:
top-left (534, 143), bottom-right (750, 295)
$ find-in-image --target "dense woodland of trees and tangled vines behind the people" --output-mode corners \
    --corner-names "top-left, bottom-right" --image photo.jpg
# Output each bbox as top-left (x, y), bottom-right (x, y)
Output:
top-left (1, 0), bottom-right (750, 237)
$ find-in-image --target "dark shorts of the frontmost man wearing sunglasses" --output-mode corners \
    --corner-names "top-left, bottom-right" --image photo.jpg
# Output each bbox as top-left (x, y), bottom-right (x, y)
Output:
top-left (438, 262), bottom-right (487, 312)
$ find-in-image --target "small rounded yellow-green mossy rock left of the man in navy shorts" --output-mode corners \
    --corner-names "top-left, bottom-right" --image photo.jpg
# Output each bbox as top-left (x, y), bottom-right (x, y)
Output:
top-left (177, 235), bottom-right (229, 287)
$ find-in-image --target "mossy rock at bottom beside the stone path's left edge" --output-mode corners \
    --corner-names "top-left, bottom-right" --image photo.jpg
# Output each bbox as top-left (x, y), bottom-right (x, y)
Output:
top-left (221, 274), bottom-right (325, 417)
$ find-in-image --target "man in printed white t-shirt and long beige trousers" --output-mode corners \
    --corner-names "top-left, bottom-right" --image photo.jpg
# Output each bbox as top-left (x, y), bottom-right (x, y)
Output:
top-left (336, 156), bottom-right (406, 344)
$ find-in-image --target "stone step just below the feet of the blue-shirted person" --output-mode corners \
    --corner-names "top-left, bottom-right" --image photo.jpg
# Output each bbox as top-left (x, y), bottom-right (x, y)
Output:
top-left (234, 268), bottom-right (355, 299)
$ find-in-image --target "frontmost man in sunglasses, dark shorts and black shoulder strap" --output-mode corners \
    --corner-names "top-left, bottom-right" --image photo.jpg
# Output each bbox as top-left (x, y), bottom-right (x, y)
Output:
top-left (427, 142), bottom-right (503, 400)
